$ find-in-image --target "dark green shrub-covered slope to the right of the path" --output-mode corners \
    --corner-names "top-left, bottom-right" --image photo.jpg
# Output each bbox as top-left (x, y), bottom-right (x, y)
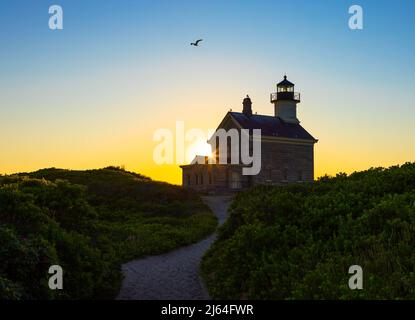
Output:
top-left (202, 163), bottom-right (415, 299)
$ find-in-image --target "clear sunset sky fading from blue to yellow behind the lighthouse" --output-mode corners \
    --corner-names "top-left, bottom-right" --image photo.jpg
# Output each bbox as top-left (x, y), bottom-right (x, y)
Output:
top-left (0, 0), bottom-right (415, 184)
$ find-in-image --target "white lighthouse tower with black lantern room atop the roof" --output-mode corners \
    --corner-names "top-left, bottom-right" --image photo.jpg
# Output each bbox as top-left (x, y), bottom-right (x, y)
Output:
top-left (271, 76), bottom-right (300, 124)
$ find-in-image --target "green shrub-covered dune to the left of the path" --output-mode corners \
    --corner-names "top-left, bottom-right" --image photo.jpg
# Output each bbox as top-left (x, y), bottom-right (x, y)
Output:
top-left (0, 167), bottom-right (217, 299)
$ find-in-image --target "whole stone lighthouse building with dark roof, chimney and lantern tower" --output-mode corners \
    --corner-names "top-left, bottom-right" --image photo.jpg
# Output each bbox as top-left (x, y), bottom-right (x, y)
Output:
top-left (181, 76), bottom-right (317, 193)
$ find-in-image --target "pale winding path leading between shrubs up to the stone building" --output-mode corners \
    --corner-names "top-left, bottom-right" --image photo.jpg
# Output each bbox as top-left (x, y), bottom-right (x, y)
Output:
top-left (117, 196), bottom-right (230, 300)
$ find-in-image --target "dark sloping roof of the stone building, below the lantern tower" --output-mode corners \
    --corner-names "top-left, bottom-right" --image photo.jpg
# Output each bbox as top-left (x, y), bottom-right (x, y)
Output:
top-left (229, 112), bottom-right (316, 140)
